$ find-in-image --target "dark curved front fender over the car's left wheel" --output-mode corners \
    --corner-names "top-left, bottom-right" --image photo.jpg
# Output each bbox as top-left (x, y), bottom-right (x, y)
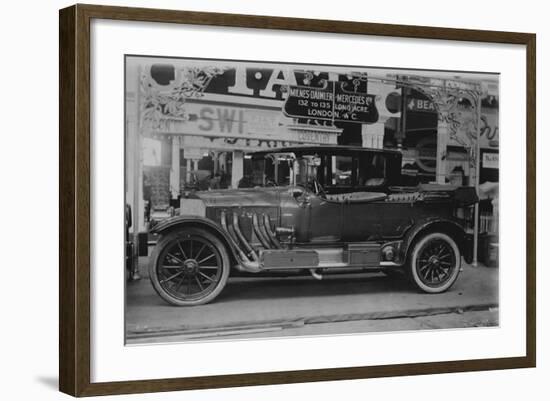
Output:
top-left (149, 215), bottom-right (238, 263)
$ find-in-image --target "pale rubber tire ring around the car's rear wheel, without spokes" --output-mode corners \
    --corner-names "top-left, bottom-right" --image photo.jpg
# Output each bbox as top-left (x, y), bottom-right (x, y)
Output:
top-left (408, 232), bottom-right (462, 294)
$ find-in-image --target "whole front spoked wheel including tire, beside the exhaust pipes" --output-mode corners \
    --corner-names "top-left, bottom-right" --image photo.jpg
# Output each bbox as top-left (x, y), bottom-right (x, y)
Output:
top-left (149, 228), bottom-right (229, 306)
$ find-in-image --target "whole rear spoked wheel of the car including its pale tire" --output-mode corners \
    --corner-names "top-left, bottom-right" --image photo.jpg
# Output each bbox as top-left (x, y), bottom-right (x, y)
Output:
top-left (410, 233), bottom-right (461, 294)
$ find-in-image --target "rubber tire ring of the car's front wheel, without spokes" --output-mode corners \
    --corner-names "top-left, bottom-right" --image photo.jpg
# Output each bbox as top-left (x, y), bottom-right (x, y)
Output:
top-left (149, 227), bottom-right (230, 306)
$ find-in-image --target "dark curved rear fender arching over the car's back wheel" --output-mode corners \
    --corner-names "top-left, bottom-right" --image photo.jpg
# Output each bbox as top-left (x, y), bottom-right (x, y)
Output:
top-left (401, 217), bottom-right (472, 263)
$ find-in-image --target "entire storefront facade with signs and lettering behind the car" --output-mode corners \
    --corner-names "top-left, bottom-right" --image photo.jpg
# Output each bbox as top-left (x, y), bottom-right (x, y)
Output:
top-left (126, 58), bottom-right (498, 253)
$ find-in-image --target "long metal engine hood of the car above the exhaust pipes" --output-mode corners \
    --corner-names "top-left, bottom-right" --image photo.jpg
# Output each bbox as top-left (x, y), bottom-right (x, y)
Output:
top-left (194, 188), bottom-right (284, 207)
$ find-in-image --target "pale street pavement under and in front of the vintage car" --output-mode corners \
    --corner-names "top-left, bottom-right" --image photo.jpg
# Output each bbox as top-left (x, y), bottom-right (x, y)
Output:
top-left (126, 259), bottom-right (498, 344)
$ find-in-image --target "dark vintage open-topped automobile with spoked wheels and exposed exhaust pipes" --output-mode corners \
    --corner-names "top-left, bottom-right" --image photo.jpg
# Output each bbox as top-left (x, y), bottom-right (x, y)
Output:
top-left (149, 146), bottom-right (478, 306)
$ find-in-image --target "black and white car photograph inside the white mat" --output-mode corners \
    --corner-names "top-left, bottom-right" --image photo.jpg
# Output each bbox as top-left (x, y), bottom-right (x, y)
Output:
top-left (121, 55), bottom-right (499, 344)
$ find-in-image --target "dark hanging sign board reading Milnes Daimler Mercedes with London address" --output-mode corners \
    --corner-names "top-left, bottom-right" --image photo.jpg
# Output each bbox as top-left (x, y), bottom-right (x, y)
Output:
top-left (283, 81), bottom-right (378, 123)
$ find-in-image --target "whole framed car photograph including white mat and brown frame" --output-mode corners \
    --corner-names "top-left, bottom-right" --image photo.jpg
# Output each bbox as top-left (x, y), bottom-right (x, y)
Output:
top-left (59, 5), bottom-right (536, 396)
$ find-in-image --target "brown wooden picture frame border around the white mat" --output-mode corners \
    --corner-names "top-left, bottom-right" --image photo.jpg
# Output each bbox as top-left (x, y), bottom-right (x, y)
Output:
top-left (59, 5), bottom-right (536, 396)
